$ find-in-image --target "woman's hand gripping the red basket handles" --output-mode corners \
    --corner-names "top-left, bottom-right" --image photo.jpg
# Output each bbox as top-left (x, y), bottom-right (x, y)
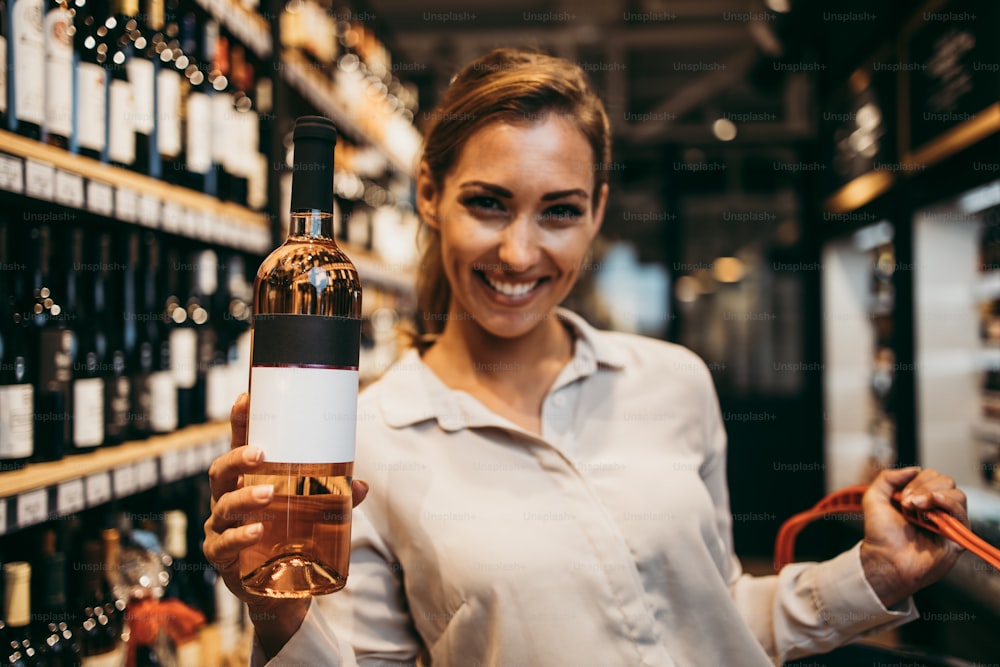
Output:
top-left (861, 468), bottom-right (969, 607)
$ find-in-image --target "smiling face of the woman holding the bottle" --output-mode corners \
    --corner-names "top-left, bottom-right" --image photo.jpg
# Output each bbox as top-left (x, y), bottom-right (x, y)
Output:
top-left (417, 114), bottom-right (607, 338)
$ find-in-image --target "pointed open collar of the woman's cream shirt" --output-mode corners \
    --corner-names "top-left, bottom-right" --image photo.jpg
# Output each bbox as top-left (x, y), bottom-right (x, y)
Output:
top-left (372, 308), bottom-right (626, 431)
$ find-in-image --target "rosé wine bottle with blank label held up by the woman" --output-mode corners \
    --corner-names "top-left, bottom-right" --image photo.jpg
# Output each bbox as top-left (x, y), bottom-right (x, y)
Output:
top-left (240, 116), bottom-right (361, 598)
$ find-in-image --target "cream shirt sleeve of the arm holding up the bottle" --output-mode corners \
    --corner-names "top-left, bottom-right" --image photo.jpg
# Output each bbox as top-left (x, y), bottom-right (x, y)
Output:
top-left (250, 508), bottom-right (422, 667)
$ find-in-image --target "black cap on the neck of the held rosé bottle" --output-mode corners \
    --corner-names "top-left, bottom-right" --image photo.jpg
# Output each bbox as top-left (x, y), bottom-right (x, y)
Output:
top-left (292, 116), bottom-right (337, 213)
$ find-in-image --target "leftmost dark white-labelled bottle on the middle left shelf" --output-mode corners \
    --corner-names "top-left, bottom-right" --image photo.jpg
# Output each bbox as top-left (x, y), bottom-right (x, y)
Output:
top-left (0, 221), bottom-right (34, 470)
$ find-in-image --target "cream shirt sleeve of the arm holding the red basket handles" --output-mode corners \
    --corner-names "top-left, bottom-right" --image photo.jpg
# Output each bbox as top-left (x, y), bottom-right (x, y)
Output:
top-left (702, 371), bottom-right (917, 665)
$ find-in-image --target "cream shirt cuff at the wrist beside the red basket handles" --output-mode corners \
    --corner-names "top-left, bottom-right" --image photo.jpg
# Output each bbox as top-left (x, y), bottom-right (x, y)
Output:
top-left (812, 542), bottom-right (917, 636)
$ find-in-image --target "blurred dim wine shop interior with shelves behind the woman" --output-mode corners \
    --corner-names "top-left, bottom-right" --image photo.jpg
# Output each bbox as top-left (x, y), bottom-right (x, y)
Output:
top-left (0, 0), bottom-right (1000, 665)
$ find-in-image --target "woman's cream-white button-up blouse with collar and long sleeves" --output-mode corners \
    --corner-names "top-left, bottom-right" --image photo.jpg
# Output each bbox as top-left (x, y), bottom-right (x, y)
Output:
top-left (251, 309), bottom-right (917, 667)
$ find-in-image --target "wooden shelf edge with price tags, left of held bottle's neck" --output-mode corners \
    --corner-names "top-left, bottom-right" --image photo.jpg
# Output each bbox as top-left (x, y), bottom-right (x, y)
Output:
top-left (0, 130), bottom-right (272, 253)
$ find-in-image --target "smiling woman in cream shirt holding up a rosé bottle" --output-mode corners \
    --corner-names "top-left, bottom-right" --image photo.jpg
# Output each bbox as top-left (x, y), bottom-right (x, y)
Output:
top-left (204, 50), bottom-right (965, 667)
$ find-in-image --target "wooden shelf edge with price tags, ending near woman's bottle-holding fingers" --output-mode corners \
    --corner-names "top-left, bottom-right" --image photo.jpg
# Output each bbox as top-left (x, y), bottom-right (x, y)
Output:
top-left (0, 421), bottom-right (230, 534)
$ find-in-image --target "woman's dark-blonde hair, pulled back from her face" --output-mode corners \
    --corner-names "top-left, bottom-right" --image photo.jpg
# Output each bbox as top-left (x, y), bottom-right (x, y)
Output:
top-left (416, 48), bottom-right (611, 342)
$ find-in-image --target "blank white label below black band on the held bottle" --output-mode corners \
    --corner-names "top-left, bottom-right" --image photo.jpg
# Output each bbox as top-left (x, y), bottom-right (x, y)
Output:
top-left (247, 366), bottom-right (358, 463)
